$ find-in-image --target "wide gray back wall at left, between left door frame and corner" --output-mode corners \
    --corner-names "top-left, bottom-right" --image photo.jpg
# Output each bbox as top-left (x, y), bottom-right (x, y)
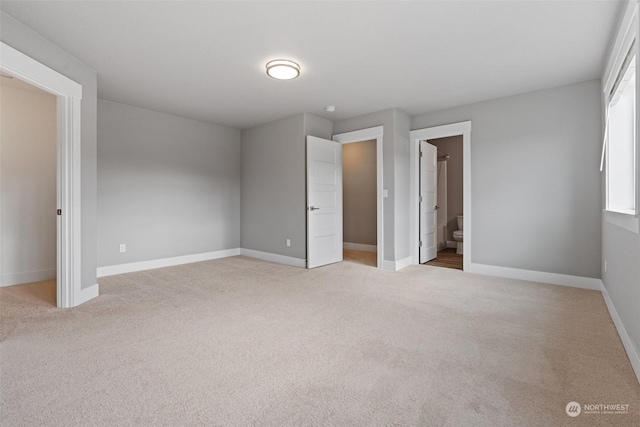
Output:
top-left (98, 100), bottom-right (241, 267)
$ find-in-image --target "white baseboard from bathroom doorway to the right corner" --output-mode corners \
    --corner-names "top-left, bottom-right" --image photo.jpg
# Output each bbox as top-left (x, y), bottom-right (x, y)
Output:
top-left (470, 263), bottom-right (602, 291)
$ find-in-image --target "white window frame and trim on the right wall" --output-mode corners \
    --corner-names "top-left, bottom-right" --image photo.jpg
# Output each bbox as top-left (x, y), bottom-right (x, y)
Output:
top-left (602, 0), bottom-right (640, 233)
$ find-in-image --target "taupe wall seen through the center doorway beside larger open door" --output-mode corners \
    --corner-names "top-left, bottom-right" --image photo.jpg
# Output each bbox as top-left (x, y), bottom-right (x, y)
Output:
top-left (342, 140), bottom-right (378, 246)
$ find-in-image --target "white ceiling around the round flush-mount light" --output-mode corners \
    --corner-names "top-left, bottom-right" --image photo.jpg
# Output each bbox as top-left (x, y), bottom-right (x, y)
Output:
top-left (0, 0), bottom-right (622, 129)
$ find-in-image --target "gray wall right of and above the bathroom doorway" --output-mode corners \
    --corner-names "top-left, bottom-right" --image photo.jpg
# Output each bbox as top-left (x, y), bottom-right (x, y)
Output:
top-left (411, 80), bottom-right (602, 278)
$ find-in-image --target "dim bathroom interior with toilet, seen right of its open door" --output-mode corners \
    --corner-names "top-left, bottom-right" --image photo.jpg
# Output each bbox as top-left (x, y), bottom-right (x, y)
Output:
top-left (425, 135), bottom-right (464, 270)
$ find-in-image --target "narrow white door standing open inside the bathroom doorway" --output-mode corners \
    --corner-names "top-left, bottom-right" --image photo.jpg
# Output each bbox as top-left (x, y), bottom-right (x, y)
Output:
top-left (419, 141), bottom-right (438, 264)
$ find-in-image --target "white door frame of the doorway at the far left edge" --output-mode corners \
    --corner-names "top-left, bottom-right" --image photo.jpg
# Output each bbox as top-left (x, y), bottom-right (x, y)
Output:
top-left (0, 42), bottom-right (84, 308)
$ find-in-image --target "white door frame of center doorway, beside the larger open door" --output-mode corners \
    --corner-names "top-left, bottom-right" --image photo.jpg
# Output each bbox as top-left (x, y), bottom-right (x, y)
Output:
top-left (333, 126), bottom-right (384, 268)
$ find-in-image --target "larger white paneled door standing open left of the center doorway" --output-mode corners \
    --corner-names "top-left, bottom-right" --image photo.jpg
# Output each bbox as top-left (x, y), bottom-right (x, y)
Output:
top-left (307, 136), bottom-right (343, 268)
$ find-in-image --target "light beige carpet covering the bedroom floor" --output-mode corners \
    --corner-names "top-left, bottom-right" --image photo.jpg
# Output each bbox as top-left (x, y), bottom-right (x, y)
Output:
top-left (0, 257), bottom-right (640, 426)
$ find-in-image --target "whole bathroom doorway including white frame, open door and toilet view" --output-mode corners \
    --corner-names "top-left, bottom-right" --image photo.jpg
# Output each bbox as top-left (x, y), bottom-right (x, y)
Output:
top-left (410, 121), bottom-right (472, 271)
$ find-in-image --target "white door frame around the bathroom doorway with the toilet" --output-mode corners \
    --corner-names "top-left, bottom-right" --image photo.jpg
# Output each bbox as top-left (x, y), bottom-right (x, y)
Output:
top-left (409, 121), bottom-right (472, 272)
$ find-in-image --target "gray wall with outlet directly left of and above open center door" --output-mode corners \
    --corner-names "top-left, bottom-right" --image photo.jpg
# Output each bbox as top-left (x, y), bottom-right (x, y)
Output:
top-left (241, 113), bottom-right (332, 260)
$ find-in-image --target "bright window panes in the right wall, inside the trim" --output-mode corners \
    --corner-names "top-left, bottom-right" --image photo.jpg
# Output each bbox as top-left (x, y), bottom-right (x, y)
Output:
top-left (606, 51), bottom-right (636, 215)
